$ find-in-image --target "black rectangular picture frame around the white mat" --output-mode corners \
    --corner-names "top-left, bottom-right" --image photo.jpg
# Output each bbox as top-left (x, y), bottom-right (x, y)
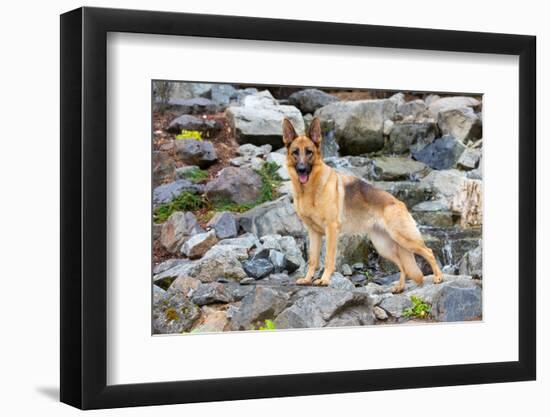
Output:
top-left (60, 7), bottom-right (536, 409)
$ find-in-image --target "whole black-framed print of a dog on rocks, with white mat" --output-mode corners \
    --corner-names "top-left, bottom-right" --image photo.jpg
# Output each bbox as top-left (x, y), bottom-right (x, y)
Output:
top-left (61, 8), bottom-right (536, 409)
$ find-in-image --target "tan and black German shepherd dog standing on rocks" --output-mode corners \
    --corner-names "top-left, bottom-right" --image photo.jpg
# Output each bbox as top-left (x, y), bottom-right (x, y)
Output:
top-left (283, 118), bottom-right (442, 293)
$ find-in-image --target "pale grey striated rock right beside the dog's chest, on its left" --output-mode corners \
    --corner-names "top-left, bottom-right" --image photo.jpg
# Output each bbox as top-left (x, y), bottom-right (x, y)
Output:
top-left (238, 196), bottom-right (306, 237)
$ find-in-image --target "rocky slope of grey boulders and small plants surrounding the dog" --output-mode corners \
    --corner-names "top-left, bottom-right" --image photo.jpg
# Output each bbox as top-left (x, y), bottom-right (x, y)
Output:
top-left (153, 82), bottom-right (483, 333)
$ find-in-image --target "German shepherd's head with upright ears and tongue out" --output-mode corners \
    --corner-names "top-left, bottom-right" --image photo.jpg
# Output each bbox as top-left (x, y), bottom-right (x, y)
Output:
top-left (283, 117), bottom-right (321, 184)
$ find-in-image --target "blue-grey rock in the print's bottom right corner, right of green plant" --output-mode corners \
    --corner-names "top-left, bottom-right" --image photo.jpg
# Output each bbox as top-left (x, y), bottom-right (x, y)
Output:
top-left (432, 283), bottom-right (482, 321)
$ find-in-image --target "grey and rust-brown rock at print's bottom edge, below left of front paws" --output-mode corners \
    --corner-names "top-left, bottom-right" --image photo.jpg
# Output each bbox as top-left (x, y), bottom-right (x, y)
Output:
top-left (231, 286), bottom-right (289, 330)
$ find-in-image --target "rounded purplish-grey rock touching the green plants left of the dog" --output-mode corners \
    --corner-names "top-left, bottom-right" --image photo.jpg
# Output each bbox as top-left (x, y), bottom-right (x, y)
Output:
top-left (205, 167), bottom-right (262, 204)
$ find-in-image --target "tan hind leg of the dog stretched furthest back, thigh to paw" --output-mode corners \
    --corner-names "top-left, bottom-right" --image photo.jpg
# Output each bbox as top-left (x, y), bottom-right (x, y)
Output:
top-left (384, 203), bottom-right (443, 284)
